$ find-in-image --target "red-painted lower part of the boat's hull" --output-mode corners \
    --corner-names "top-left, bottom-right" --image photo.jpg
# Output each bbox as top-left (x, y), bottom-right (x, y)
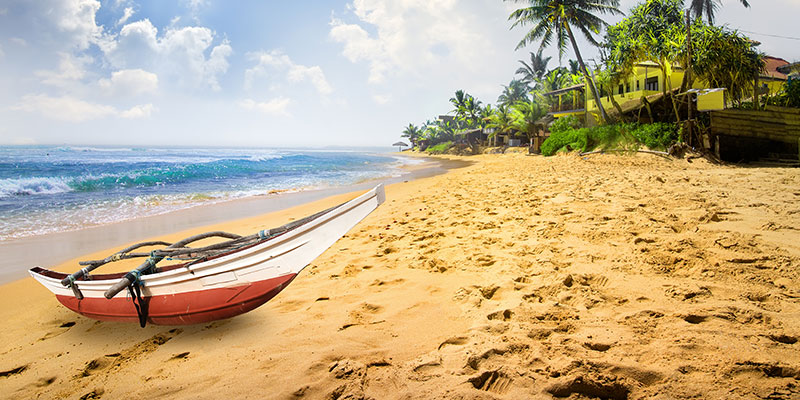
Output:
top-left (56, 274), bottom-right (297, 325)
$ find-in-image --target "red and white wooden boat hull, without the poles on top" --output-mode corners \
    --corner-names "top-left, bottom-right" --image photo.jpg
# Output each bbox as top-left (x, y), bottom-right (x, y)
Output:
top-left (30, 185), bottom-right (385, 325)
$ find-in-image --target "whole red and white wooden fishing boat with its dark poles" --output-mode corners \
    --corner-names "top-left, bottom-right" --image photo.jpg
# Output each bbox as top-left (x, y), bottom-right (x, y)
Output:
top-left (30, 185), bottom-right (385, 327)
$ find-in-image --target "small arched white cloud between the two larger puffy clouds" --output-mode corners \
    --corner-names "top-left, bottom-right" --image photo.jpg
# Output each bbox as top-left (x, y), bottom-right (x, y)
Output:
top-left (244, 50), bottom-right (333, 95)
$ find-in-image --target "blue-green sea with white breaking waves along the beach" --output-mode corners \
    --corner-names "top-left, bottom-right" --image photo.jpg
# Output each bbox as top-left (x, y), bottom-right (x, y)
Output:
top-left (0, 146), bottom-right (412, 241)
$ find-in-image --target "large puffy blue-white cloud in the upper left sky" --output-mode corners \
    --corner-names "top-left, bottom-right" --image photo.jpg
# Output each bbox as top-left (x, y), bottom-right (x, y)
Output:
top-left (104, 19), bottom-right (233, 90)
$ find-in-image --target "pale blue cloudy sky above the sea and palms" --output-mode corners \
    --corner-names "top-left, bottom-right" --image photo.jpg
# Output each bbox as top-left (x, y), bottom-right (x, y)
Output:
top-left (0, 0), bottom-right (800, 147)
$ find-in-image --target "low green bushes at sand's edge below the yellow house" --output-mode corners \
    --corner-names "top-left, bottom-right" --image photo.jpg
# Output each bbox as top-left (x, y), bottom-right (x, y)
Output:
top-left (542, 117), bottom-right (678, 156)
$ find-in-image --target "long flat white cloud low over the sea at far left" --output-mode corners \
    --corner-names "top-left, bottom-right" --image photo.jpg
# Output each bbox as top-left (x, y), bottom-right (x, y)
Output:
top-left (11, 94), bottom-right (153, 122)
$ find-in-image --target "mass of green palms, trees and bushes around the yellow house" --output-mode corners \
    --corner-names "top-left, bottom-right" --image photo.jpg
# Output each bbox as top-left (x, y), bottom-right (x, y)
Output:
top-left (402, 0), bottom-right (764, 155)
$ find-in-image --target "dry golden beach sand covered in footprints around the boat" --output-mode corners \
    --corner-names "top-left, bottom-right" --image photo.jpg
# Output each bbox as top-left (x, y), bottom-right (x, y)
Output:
top-left (0, 154), bottom-right (800, 399)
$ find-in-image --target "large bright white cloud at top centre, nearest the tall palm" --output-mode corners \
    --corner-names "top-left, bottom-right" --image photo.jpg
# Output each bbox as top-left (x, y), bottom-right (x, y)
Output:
top-left (329, 0), bottom-right (492, 83)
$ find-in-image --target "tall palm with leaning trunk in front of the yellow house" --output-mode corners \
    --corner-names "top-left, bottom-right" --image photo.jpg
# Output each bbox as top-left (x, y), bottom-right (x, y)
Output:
top-left (507, 0), bottom-right (622, 122)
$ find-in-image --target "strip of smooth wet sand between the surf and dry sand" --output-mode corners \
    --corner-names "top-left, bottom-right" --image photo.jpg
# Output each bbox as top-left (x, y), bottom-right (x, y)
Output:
top-left (0, 155), bottom-right (468, 285)
